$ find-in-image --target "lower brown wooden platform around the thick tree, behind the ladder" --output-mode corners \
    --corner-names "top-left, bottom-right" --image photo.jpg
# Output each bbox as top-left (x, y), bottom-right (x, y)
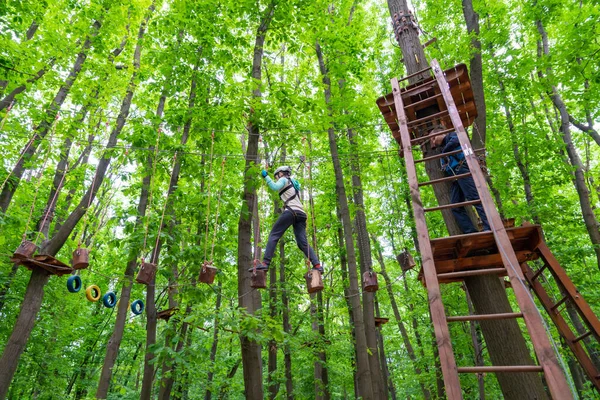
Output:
top-left (419, 225), bottom-right (542, 285)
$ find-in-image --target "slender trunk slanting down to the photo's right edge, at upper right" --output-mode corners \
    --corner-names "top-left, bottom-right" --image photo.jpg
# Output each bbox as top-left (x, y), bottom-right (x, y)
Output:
top-left (536, 20), bottom-right (600, 268)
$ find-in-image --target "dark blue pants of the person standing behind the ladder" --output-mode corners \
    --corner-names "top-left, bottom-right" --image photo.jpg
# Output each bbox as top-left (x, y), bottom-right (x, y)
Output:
top-left (450, 164), bottom-right (490, 233)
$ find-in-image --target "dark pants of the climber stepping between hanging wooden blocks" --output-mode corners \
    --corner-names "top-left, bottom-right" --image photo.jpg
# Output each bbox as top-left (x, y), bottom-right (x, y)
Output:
top-left (263, 209), bottom-right (320, 266)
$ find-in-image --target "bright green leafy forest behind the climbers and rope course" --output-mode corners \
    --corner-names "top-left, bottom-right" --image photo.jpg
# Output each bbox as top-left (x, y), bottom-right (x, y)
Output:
top-left (0, 0), bottom-right (600, 399)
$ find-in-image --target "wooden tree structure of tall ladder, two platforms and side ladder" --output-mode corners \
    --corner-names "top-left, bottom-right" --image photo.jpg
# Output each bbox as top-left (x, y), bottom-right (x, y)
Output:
top-left (377, 53), bottom-right (600, 400)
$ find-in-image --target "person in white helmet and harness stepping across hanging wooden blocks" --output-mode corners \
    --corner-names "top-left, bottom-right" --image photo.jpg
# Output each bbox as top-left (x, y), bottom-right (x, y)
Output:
top-left (249, 166), bottom-right (323, 274)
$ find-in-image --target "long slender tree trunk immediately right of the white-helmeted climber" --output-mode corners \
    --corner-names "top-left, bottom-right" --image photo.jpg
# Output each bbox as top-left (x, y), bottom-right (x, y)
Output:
top-left (316, 43), bottom-right (372, 399)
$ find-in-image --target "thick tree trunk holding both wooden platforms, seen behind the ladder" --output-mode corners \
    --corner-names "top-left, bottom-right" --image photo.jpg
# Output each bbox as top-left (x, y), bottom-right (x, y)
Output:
top-left (388, 0), bottom-right (546, 398)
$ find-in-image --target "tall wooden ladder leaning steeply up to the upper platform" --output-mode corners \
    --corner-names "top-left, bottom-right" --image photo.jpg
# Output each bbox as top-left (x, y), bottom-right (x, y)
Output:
top-left (391, 60), bottom-right (573, 400)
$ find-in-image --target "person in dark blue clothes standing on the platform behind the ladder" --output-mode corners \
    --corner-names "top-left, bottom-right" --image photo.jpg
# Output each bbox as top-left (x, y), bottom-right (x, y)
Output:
top-left (430, 126), bottom-right (490, 233)
